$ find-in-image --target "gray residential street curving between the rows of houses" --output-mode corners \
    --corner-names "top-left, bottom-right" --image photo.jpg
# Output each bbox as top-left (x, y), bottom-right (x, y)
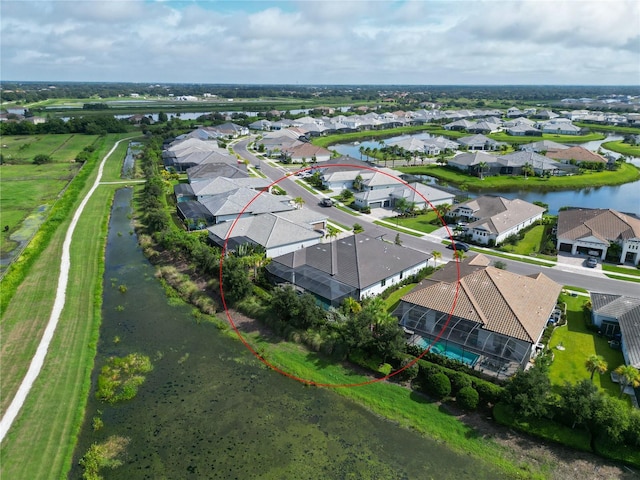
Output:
top-left (233, 139), bottom-right (640, 296)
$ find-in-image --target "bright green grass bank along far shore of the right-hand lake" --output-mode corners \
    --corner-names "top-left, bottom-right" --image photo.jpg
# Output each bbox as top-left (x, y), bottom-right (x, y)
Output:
top-left (397, 163), bottom-right (640, 192)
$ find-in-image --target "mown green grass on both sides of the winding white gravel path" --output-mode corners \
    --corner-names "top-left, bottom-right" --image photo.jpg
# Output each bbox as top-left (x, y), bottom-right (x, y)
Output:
top-left (0, 136), bottom-right (131, 479)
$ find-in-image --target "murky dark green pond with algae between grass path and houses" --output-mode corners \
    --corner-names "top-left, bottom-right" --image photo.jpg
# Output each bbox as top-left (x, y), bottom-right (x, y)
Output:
top-left (69, 189), bottom-right (505, 480)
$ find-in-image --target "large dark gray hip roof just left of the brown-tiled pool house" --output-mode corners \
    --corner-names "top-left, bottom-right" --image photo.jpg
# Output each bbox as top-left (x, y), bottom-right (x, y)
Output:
top-left (272, 233), bottom-right (431, 290)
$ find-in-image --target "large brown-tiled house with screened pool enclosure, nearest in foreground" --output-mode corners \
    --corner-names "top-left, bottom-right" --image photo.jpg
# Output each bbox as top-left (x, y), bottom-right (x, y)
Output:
top-left (394, 255), bottom-right (562, 376)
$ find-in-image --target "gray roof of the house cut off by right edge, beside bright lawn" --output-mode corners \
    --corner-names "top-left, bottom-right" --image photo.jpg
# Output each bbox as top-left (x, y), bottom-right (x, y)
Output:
top-left (591, 292), bottom-right (640, 368)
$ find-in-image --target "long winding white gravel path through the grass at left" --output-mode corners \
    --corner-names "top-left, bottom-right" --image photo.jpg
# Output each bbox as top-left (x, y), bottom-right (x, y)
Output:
top-left (0, 138), bottom-right (130, 442)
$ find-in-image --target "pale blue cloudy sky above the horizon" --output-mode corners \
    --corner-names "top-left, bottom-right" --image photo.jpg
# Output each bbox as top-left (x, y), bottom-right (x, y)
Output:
top-left (0, 0), bottom-right (640, 85)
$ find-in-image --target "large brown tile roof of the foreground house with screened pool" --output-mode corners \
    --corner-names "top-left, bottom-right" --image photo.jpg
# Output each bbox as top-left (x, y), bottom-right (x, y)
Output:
top-left (402, 256), bottom-right (562, 343)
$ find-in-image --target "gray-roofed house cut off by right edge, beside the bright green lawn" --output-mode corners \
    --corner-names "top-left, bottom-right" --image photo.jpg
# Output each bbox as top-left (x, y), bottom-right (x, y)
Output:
top-left (590, 292), bottom-right (640, 369)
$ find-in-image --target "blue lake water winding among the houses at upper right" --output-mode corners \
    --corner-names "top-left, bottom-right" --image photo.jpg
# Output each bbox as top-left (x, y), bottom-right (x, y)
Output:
top-left (329, 133), bottom-right (640, 215)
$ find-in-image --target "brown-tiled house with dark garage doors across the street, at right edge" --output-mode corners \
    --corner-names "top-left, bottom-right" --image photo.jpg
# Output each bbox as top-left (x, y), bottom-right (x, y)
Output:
top-left (557, 208), bottom-right (640, 265)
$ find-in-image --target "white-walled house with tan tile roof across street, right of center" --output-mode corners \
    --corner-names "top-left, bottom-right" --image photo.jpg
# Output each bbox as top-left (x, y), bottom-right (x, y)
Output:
top-left (447, 195), bottom-right (544, 245)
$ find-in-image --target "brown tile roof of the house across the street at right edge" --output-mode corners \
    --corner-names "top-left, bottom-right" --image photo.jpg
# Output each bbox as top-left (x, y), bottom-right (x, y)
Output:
top-left (558, 208), bottom-right (640, 243)
